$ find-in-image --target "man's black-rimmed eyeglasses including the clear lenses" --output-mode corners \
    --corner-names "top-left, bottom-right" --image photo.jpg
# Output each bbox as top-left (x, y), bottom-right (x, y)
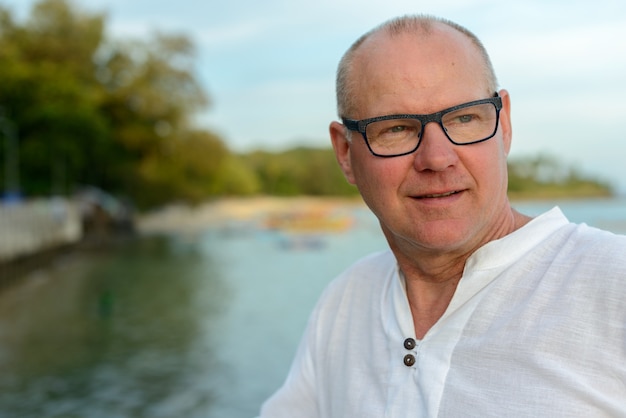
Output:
top-left (342, 93), bottom-right (502, 157)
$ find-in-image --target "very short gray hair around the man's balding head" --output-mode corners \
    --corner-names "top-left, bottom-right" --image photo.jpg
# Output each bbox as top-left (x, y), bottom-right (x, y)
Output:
top-left (336, 15), bottom-right (498, 117)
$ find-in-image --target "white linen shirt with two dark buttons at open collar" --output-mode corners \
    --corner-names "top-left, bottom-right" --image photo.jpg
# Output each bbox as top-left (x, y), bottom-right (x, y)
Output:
top-left (261, 208), bottom-right (626, 418)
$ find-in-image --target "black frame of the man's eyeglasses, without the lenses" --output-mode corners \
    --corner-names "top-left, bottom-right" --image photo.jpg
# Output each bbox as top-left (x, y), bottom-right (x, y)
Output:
top-left (341, 92), bottom-right (502, 158)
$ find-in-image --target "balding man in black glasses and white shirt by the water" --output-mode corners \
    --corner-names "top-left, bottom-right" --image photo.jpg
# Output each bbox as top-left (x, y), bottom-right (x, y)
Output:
top-left (261, 16), bottom-right (626, 418)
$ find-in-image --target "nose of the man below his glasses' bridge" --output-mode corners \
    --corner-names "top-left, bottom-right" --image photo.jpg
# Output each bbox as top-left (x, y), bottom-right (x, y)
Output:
top-left (414, 122), bottom-right (458, 171)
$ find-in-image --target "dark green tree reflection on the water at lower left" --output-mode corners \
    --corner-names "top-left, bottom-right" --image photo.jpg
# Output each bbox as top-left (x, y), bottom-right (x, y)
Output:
top-left (0, 239), bottom-right (229, 418)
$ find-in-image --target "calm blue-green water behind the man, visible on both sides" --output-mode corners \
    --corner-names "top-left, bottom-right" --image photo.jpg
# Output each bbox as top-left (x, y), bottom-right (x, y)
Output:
top-left (0, 199), bottom-right (626, 418)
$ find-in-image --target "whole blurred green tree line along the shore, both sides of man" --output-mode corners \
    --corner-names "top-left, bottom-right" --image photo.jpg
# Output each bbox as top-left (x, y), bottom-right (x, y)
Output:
top-left (0, 0), bottom-right (611, 208)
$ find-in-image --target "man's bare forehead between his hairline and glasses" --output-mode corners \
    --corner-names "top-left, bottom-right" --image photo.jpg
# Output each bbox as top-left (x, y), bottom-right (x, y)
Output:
top-left (351, 25), bottom-right (491, 117)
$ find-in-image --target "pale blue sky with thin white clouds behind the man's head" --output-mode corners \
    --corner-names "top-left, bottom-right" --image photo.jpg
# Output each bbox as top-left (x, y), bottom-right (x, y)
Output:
top-left (7, 0), bottom-right (626, 194)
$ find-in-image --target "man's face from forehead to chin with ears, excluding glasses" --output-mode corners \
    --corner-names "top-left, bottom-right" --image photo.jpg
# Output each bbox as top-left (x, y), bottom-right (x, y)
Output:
top-left (331, 27), bottom-right (511, 255)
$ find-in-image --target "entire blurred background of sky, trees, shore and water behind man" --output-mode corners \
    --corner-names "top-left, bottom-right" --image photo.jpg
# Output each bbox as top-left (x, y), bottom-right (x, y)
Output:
top-left (0, 0), bottom-right (626, 418)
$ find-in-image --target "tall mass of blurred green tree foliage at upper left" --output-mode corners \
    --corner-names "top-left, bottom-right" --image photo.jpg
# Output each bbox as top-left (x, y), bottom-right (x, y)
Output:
top-left (0, 0), bottom-right (233, 205)
